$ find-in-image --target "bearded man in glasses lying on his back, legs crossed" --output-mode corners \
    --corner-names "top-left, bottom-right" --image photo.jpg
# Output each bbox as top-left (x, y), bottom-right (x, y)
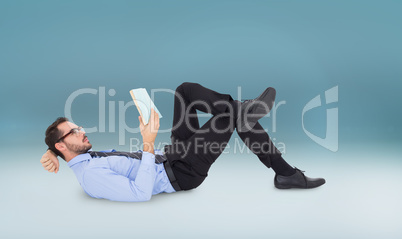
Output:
top-left (41, 82), bottom-right (325, 202)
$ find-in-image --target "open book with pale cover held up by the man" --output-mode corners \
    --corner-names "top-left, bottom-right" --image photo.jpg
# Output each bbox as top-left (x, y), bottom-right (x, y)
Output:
top-left (130, 88), bottom-right (162, 125)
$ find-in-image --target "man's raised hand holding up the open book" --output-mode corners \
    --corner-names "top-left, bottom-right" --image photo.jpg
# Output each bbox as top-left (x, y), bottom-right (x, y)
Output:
top-left (138, 108), bottom-right (159, 154)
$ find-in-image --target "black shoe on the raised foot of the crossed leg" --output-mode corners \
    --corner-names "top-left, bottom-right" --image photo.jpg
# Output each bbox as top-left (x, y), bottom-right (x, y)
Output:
top-left (236, 87), bottom-right (276, 132)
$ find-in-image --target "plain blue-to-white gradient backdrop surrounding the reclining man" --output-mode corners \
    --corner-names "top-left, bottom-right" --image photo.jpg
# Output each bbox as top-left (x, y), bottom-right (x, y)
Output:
top-left (0, 1), bottom-right (402, 238)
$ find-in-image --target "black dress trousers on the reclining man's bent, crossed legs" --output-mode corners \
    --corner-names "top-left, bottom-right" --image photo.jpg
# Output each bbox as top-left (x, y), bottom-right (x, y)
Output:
top-left (165, 82), bottom-right (281, 190)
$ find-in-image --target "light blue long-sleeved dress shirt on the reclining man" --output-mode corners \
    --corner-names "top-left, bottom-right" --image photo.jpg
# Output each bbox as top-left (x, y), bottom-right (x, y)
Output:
top-left (67, 149), bottom-right (175, 202)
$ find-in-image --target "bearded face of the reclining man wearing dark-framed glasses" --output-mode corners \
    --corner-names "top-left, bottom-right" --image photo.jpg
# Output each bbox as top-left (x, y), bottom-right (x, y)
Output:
top-left (57, 121), bottom-right (92, 154)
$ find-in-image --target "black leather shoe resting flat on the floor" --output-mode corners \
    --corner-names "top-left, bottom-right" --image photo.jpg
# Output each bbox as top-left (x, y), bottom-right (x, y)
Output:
top-left (274, 168), bottom-right (325, 189)
